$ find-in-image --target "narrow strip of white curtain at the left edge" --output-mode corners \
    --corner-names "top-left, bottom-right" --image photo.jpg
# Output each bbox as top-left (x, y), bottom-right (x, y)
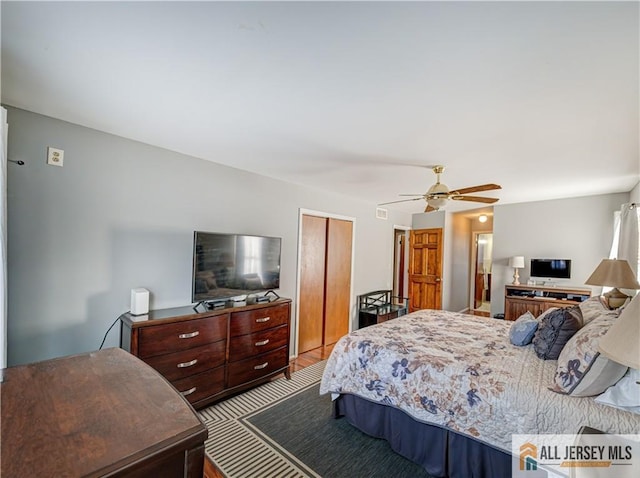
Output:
top-left (0, 108), bottom-right (8, 372)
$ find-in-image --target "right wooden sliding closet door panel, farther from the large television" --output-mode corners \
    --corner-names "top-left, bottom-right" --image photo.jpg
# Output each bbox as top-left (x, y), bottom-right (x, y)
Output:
top-left (323, 218), bottom-right (353, 345)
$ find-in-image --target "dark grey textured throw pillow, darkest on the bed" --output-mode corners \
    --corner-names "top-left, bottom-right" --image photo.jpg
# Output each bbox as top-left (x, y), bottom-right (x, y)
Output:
top-left (533, 305), bottom-right (582, 360)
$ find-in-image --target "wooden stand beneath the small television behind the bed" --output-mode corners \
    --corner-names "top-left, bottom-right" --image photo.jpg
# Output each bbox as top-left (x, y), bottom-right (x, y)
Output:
top-left (504, 285), bottom-right (591, 320)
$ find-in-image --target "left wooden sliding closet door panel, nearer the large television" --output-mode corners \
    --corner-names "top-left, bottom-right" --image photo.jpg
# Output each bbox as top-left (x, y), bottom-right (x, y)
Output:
top-left (298, 215), bottom-right (327, 353)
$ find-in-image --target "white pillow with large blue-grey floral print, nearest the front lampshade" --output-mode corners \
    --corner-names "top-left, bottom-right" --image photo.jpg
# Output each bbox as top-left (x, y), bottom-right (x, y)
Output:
top-left (551, 315), bottom-right (627, 397)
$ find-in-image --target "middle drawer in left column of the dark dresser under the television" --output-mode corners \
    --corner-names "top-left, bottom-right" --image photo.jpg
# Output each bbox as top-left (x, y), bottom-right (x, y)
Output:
top-left (145, 340), bottom-right (227, 381)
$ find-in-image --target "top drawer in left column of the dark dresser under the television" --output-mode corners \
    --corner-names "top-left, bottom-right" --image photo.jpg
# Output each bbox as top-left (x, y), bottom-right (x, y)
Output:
top-left (138, 314), bottom-right (228, 358)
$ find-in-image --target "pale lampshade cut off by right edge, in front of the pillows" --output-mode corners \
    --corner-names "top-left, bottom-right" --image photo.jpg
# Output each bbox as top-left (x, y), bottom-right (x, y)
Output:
top-left (598, 294), bottom-right (640, 369)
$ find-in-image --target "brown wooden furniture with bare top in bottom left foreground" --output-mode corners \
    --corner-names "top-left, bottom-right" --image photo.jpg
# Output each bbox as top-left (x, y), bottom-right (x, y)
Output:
top-left (0, 348), bottom-right (207, 478)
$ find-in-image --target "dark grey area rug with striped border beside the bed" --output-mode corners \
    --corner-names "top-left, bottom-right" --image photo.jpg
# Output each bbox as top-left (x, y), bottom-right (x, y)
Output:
top-left (200, 362), bottom-right (429, 478)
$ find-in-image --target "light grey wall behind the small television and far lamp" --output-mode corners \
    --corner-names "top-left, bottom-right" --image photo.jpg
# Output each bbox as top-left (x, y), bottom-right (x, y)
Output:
top-left (491, 193), bottom-right (629, 315)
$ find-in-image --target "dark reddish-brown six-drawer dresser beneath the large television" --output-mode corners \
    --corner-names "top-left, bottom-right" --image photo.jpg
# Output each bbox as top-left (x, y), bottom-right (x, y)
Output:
top-left (120, 298), bottom-right (291, 408)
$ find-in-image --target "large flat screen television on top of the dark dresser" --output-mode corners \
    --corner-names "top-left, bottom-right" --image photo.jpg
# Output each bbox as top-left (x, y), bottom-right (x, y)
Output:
top-left (191, 231), bottom-right (282, 302)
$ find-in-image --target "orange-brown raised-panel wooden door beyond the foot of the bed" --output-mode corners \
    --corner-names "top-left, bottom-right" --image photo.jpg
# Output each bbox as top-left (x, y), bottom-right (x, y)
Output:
top-left (409, 229), bottom-right (442, 312)
